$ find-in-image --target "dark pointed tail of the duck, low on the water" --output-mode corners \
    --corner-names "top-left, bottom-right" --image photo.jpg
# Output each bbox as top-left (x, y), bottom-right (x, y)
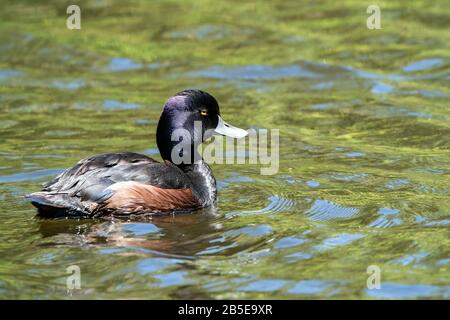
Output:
top-left (25, 191), bottom-right (89, 218)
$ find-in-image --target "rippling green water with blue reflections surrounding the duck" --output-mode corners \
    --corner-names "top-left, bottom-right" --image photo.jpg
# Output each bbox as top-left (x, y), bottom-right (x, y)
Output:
top-left (0, 0), bottom-right (450, 299)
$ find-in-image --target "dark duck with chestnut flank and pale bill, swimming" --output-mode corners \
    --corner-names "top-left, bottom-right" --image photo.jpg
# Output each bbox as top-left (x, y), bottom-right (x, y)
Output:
top-left (26, 89), bottom-right (247, 217)
